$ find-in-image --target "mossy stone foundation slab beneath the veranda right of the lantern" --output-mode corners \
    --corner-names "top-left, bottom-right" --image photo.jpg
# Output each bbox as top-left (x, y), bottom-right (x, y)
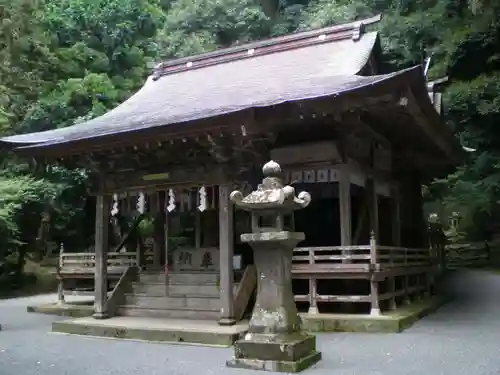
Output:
top-left (300, 297), bottom-right (448, 333)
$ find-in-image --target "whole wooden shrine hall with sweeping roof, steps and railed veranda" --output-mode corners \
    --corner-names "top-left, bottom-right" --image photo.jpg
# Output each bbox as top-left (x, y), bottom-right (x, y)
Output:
top-left (0, 16), bottom-right (462, 325)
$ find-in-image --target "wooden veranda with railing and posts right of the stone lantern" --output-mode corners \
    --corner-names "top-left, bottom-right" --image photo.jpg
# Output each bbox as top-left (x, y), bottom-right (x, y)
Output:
top-left (292, 238), bottom-right (437, 315)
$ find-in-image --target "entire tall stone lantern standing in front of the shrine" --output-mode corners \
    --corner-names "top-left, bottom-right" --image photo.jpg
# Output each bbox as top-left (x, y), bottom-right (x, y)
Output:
top-left (227, 161), bottom-right (321, 372)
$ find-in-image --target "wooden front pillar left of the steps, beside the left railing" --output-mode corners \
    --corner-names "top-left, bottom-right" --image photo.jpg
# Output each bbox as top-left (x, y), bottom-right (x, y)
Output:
top-left (93, 195), bottom-right (109, 319)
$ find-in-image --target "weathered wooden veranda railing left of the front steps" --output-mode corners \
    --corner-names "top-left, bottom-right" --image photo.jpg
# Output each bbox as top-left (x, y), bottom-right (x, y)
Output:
top-left (56, 251), bottom-right (137, 303)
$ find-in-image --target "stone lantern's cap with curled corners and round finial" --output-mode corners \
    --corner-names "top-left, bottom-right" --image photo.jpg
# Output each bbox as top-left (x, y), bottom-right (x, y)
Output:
top-left (230, 160), bottom-right (311, 211)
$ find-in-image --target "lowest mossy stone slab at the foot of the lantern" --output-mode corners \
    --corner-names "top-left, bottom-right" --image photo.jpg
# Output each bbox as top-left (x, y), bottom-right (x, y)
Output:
top-left (226, 351), bottom-right (321, 373)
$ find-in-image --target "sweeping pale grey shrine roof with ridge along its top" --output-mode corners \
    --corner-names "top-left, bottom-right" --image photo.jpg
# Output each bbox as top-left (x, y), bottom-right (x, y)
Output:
top-left (0, 16), bottom-right (382, 150)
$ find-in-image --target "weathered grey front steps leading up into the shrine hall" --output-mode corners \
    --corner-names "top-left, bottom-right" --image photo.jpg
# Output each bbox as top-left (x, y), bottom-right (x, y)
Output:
top-left (118, 271), bottom-right (220, 320)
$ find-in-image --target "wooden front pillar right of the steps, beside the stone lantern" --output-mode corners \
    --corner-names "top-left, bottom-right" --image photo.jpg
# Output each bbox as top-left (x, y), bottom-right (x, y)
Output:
top-left (219, 185), bottom-right (236, 325)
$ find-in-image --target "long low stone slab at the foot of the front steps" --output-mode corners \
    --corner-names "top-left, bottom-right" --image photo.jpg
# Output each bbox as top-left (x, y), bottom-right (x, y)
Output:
top-left (52, 316), bottom-right (248, 347)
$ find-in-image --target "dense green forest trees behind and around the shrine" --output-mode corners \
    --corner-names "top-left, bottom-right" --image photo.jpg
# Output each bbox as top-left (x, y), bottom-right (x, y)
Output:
top-left (0, 0), bottom-right (500, 290)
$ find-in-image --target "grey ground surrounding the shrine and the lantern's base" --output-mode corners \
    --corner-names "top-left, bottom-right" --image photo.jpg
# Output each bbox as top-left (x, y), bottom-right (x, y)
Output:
top-left (0, 271), bottom-right (500, 375)
